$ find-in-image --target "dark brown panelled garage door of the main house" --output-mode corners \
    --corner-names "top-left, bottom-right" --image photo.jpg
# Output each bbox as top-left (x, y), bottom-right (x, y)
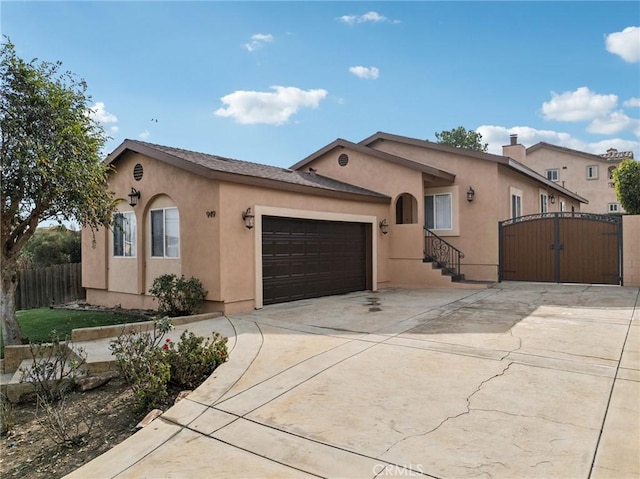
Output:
top-left (262, 216), bottom-right (371, 304)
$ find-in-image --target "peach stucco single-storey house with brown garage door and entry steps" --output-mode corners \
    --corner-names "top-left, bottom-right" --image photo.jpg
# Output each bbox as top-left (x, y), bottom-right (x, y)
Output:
top-left (82, 132), bottom-right (585, 314)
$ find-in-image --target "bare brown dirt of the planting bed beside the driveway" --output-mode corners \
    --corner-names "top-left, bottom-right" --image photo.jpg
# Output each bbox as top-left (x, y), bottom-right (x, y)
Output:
top-left (0, 378), bottom-right (179, 479)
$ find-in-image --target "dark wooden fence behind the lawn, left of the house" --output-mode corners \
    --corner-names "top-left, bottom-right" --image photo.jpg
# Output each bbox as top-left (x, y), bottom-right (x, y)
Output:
top-left (16, 263), bottom-right (86, 310)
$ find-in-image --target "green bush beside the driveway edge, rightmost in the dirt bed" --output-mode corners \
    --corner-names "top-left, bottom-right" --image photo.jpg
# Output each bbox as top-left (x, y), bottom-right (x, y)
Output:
top-left (163, 331), bottom-right (228, 389)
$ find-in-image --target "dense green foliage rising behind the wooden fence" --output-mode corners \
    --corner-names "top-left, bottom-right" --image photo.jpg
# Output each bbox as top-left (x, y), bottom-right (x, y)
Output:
top-left (19, 225), bottom-right (82, 268)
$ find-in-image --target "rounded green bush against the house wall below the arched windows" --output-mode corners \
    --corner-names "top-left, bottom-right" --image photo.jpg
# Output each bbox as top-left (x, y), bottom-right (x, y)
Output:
top-left (149, 274), bottom-right (207, 316)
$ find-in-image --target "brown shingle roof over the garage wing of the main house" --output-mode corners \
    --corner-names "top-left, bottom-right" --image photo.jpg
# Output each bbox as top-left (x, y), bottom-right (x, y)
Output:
top-left (106, 140), bottom-right (389, 199)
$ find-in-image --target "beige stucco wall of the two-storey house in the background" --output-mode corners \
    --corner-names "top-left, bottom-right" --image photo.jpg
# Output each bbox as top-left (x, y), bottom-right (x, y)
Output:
top-left (522, 148), bottom-right (619, 214)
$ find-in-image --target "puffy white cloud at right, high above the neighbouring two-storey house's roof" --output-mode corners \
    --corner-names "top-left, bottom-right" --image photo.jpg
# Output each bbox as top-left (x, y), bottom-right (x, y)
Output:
top-left (542, 86), bottom-right (618, 121)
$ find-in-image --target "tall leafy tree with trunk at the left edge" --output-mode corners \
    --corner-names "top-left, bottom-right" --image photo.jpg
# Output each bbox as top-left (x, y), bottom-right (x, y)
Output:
top-left (0, 38), bottom-right (115, 344)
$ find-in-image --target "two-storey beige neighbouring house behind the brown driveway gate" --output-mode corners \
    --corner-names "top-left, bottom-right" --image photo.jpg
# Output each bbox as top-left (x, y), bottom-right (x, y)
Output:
top-left (503, 135), bottom-right (633, 214)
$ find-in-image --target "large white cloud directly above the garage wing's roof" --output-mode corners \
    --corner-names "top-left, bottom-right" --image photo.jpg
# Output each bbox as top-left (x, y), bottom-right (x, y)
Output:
top-left (215, 86), bottom-right (327, 125)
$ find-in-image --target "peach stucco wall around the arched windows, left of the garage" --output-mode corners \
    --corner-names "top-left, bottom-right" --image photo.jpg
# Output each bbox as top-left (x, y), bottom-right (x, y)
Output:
top-left (82, 153), bottom-right (220, 309)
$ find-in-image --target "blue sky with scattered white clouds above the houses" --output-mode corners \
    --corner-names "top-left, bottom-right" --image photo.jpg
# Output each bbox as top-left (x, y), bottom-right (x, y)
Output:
top-left (0, 1), bottom-right (640, 166)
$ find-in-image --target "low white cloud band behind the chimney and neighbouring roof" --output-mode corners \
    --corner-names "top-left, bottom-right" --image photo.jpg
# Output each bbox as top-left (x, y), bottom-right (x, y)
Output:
top-left (476, 125), bottom-right (640, 155)
